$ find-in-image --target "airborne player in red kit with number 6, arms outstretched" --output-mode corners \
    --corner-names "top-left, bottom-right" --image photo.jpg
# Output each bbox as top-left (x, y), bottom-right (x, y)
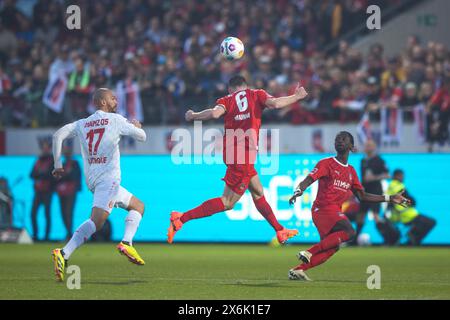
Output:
top-left (167, 76), bottom-right (307, 243)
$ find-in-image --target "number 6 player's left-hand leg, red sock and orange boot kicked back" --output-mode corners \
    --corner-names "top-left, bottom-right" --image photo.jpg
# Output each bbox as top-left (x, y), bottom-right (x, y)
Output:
top-left (167, 186), bottom-right (242, 243)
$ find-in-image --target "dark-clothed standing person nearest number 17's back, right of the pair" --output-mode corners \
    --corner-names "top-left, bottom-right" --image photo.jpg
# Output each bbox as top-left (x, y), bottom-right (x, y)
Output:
top-left (56, 140), bottom-right (81, 239)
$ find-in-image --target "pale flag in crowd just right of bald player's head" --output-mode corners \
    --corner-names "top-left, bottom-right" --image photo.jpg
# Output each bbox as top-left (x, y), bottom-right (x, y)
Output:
top-left (116, 80), bottom-right (144, 122)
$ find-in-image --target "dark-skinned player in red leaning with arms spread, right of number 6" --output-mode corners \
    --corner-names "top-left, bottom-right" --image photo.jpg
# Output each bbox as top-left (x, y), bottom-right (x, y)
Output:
top-left (289, 131), bottom-right (410, 280)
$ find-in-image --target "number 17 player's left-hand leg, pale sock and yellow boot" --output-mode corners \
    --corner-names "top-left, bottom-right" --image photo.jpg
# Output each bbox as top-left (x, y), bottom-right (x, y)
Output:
top-left (52, 207), bottom-right (109, 281)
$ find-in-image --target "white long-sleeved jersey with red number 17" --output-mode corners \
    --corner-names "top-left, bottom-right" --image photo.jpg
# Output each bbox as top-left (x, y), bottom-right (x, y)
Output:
top-left (53, 110), bottom-right (146, 191)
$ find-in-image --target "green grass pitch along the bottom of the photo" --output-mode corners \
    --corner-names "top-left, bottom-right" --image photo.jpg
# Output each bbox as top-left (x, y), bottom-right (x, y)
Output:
top-left (0, 244), bottom-right (450, 299)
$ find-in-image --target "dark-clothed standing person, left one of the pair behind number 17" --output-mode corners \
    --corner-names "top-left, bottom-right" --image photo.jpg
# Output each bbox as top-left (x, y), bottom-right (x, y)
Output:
top-left (30, 138), bottom-right (54, 241)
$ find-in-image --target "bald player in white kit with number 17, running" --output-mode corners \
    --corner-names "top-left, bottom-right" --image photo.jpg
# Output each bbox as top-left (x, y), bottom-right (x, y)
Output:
top-left (52, 88), bottom-right (146, 281)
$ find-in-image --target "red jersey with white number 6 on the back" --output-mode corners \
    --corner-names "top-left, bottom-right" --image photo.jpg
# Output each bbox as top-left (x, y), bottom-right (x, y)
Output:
top-left (216, 89), bottom-right (272, 164)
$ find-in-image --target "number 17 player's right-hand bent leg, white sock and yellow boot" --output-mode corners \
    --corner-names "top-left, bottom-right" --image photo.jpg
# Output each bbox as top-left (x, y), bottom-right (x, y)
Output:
top-left (117, 194), bottom-right (145, 265)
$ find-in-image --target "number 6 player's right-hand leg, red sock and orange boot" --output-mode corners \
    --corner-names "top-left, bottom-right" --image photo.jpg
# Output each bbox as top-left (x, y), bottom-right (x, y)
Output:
top-left (248, 175), bottom-right (298, 243)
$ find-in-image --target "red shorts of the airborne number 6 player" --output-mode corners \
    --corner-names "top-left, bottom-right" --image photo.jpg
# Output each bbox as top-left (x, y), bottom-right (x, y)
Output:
top-left (222, 164), bottom-right (258, 195)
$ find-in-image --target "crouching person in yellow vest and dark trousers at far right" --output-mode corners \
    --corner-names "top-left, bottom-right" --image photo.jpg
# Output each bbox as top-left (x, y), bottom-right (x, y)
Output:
top-left (387, 169), bottom-right (436, 245)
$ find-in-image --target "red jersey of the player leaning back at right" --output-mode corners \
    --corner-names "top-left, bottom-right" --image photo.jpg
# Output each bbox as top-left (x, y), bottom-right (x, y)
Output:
top-left (309, 157), bottom-right (364, 213)
